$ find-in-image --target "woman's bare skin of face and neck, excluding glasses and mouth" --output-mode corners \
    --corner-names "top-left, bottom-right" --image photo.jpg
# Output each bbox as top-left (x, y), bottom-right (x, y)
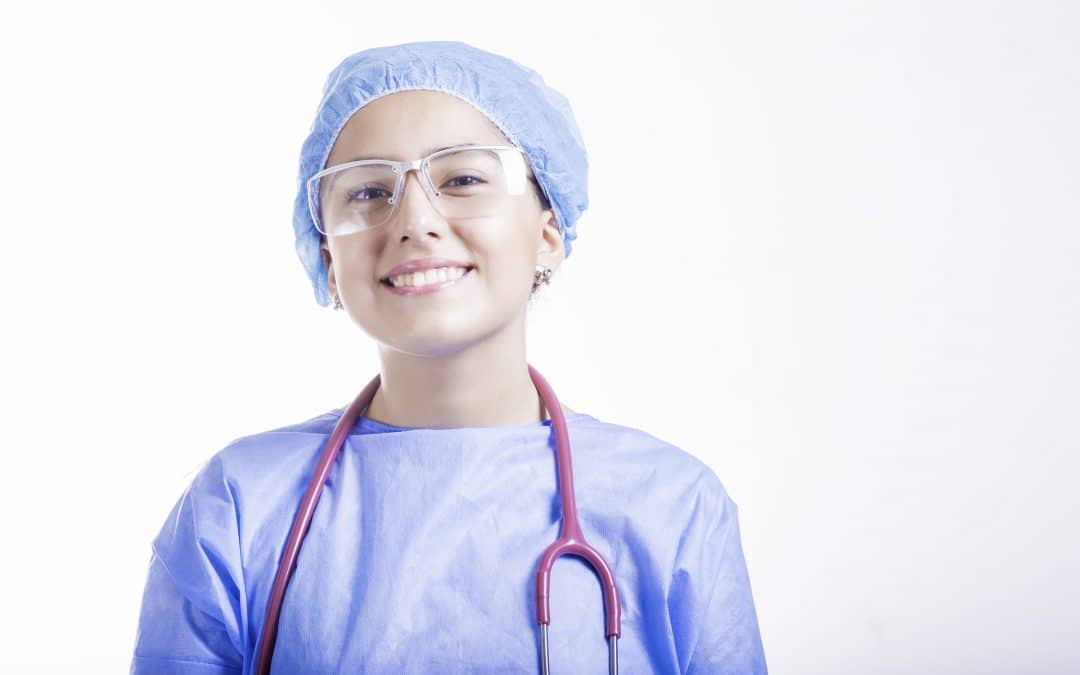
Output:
top-left (322, 91), bottom-right (573, 428)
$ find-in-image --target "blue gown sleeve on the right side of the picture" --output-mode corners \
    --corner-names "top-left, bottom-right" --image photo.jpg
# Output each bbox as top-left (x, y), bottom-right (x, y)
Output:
top-left (673, 470), bottom-right (768, 675)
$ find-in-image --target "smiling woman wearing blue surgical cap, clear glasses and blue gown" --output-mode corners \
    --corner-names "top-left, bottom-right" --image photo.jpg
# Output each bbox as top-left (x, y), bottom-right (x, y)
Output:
top-left (132, 42), bottom-right (766, 675)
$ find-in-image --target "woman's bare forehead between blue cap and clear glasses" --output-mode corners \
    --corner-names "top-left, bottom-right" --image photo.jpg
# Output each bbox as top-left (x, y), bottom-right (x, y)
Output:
top-left (326, 90), bottom-right (510, 166)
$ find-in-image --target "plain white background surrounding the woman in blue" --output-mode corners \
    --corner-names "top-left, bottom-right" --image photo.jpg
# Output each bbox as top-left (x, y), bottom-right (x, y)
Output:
top-left (0, 0), bottom-right (1080, 675)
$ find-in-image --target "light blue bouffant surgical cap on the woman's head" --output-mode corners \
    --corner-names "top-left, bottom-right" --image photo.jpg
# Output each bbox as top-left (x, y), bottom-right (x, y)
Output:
top-left (293, 42), bottom-right (589, 307)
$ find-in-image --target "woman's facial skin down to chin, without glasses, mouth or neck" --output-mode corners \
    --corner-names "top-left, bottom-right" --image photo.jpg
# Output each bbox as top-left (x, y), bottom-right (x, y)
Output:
top-left (322, 91), bottom-right (564, 356)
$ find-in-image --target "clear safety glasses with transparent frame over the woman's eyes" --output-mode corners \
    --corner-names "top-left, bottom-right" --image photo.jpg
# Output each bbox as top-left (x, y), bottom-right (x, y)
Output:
top-left (308, 145), bottom-right (535, 237)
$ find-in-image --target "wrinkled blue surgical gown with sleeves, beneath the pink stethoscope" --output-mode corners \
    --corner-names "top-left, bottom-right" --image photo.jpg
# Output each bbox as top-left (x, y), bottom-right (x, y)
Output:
top-left (131, 408), bottom-right (767, 675)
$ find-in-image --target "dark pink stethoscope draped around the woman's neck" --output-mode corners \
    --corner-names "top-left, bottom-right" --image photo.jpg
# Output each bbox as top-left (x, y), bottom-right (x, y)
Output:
top-left (256, 365), bottom-right (622, 675)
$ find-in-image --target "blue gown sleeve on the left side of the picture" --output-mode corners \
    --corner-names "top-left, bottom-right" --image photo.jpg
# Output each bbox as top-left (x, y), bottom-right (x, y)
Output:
top-left (130, 457), bottom-right (245, 675)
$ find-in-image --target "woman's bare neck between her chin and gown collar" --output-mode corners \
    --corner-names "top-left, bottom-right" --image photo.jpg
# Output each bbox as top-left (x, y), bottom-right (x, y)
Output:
top-left (364, 315), bottom-right (572, 429)
